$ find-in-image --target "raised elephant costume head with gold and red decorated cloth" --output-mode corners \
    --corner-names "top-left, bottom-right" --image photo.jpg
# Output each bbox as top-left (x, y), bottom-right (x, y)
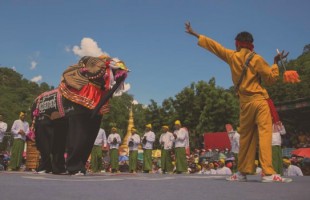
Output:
top-left (44, 55), bottom-right (129, 117)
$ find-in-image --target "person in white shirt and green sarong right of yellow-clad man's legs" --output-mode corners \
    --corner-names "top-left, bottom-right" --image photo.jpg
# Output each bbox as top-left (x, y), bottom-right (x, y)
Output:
top-left (271, 121), bottom-right (286, 175)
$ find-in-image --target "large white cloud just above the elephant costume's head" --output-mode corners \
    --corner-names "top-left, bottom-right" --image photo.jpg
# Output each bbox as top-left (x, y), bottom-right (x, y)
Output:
top-left (72, 38), bottom-right (108, 57)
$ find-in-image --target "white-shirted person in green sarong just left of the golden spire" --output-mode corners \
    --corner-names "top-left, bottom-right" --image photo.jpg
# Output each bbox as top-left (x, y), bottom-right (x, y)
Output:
top-left (108, 127), bottom-right (121, 173)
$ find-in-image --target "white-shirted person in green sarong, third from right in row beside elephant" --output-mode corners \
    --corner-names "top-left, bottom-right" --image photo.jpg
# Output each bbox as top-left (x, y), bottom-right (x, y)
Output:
top-left (142, 124), bottom-right (155, 173)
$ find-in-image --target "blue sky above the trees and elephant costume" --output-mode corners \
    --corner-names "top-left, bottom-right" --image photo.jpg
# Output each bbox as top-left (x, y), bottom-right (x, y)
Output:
top-left (0, 0), bottom-right (310, 104)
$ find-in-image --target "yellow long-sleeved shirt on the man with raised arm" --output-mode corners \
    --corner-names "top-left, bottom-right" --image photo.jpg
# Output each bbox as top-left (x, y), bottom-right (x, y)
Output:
top-left (198, 35), bottom-right (279, 102)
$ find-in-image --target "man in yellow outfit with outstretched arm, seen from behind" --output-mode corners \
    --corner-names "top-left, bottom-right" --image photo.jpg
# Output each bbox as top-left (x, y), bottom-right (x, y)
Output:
top-left (185, 22), bottom-right (291, 182)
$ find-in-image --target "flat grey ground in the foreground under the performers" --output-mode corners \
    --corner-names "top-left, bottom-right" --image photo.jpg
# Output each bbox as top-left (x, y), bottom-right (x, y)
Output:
top-left (0, 172), bottom-right (310, 200)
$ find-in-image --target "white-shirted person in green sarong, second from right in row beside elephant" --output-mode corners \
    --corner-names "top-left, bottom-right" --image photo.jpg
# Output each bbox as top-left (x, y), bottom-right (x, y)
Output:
top-left (159, 125), bottom-right (174, 174)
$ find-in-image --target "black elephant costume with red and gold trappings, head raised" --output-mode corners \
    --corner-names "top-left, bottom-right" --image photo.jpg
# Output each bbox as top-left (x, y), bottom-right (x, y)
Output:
top-left (32, 57), bottom-right (128, 174)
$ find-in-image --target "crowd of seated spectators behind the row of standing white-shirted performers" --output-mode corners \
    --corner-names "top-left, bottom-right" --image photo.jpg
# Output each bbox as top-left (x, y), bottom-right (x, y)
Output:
top-left (0, 125), bottom-right (310, 175)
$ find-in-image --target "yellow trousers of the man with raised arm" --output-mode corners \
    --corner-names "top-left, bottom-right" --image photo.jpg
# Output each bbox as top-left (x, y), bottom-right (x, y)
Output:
top-left (238, 99), bottom-right (276, 175)
